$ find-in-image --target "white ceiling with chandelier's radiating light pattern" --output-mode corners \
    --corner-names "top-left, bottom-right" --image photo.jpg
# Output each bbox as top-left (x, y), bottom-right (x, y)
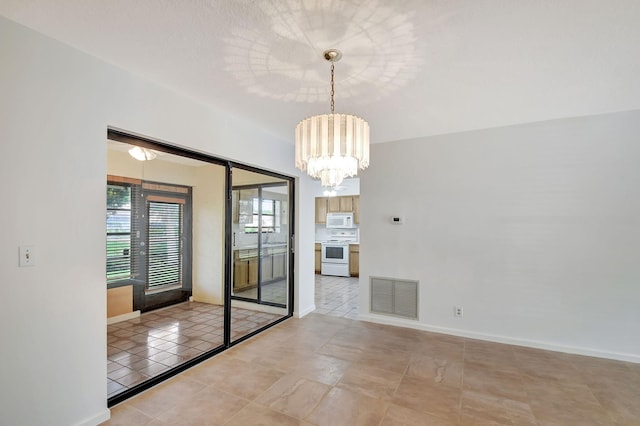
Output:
top-left (0, 0), bottom-right (640, 142)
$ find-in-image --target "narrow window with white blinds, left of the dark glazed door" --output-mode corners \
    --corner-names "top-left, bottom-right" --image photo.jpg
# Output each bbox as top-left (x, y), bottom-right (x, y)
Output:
top-left (107, 184), bottom-right (131, 281)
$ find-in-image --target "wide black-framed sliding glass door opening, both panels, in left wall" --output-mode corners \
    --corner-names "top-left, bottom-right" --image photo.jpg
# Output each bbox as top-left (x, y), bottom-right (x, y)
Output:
top-left (105, 130), bottom-right (293, 406)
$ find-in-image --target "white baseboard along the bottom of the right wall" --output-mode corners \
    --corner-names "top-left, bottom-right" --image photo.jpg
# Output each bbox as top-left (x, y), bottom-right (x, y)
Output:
top-left (358, 314), bottom-right (640, 364)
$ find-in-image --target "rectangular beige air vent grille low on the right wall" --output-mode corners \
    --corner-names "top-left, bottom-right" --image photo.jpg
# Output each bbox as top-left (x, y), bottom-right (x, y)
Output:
top-left (369, 277), bottom-right (418, 320)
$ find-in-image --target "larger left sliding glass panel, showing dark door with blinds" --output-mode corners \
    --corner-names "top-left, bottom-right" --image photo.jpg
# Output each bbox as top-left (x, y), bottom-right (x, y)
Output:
top-left (106, 133), bottom-right (228, 405)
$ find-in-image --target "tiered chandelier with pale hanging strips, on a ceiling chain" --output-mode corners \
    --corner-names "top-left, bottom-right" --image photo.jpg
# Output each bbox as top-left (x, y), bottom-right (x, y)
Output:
top-left (295, 49), bottom-right (369, 188)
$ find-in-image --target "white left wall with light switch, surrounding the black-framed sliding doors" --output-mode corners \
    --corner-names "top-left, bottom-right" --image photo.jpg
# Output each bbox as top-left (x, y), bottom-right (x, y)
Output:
top-left (0, 18), bottom-right (314, 425)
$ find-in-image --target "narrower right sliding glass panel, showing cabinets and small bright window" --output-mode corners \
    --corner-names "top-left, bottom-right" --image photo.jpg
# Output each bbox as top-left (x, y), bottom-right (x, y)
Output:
top-left (231, 168), bottom-right (292, 340)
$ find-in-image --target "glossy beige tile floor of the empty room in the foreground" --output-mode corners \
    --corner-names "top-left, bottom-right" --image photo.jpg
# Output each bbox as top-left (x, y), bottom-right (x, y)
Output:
top-left (106, 313), bottom-right (640, 426)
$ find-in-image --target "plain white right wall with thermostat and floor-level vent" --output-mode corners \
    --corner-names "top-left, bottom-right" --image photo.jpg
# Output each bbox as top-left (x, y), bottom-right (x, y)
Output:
top-left (360, 111), bottom-right (640, 362)
